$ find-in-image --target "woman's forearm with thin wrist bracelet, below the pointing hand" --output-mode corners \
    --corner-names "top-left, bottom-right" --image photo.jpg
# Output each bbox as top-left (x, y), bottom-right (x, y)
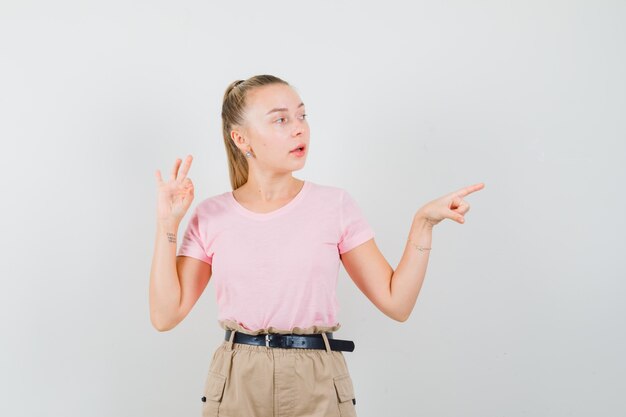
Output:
top-left (391, 212), bottom-right (433, 321)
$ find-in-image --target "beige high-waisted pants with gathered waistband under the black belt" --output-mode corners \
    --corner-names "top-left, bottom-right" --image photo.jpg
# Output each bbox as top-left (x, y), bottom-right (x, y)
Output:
top-left (202, 323), bottom-right (356, 417)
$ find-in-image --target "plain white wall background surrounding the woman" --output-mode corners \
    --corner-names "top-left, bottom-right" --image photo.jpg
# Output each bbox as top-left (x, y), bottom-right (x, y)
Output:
top-left (0, 0), bottom-right (626, 417)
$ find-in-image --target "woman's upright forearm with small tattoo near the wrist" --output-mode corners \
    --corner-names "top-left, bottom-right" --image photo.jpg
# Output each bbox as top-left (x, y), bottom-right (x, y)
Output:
top-left (150, 223), bottom-right (181, 330)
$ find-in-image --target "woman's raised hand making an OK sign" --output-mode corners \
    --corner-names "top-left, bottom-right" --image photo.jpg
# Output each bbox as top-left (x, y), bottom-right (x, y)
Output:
top-left (155, 155), bottom-right (193, 226)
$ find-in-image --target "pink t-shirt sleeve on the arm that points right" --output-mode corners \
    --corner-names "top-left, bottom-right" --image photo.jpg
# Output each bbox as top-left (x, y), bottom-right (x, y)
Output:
top-left (337, 190), bottom-right (375, 254)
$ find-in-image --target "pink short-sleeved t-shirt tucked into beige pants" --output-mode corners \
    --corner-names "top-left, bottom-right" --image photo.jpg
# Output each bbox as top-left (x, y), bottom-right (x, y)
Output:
top-left (178, 181), bottom-right (374, 331)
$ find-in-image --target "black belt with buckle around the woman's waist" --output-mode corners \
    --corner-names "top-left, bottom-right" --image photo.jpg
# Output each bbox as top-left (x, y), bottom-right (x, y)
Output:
top-left (224, 330), bottom-right (354, 352)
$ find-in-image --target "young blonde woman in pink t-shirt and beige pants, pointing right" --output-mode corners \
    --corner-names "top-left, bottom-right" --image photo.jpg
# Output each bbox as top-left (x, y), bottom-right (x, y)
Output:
top-left (150, 75), bottom-right (484, 417)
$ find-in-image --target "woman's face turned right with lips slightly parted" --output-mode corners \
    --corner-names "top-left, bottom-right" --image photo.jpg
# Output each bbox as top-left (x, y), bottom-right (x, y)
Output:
top-left (234, 84), bottom-right (310, 172)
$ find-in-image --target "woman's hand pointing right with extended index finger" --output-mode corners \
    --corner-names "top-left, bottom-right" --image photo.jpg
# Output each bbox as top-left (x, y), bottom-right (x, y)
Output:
top-left (415, 182), bottom-right (485, 226)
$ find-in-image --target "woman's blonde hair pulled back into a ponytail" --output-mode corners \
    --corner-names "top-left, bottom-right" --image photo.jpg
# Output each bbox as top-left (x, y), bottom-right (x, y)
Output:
top-left (222, 74), bottom-right (289, 190)
